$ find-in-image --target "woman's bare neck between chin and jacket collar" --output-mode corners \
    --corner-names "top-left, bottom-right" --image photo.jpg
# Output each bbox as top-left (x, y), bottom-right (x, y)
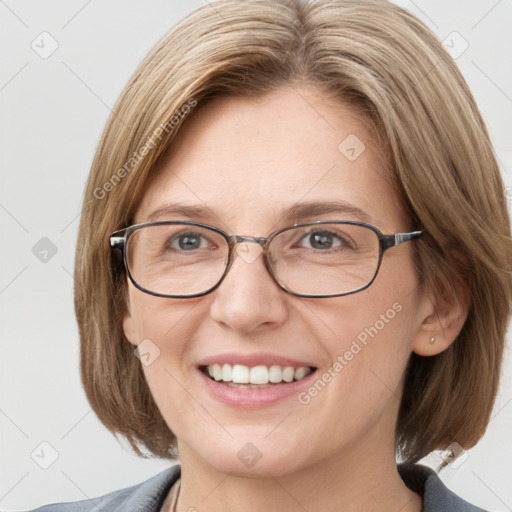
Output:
top-left (171, 434), bottom-right (422, 512)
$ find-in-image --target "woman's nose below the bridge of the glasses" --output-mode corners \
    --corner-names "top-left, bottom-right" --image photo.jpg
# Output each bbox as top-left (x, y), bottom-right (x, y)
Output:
top-left (210, 242), bottom-right (290, 334)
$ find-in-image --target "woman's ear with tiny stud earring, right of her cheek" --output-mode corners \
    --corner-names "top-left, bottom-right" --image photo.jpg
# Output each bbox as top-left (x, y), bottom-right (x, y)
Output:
top-left (412, 285), bottom-right (471, 356)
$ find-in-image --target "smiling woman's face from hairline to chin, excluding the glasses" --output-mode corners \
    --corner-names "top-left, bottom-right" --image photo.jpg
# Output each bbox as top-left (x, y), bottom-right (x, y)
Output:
top-left (124, 87), bottom-right (431, 476)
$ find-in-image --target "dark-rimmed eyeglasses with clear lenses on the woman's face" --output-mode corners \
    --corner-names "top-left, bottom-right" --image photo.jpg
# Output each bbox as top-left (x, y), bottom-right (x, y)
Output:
top-left (110, 221), bottom-right (421, 298)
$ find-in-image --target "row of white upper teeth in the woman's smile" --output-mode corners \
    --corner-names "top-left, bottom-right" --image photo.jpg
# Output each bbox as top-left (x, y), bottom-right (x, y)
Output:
top-left (207, 363), bottom-right (311, 384)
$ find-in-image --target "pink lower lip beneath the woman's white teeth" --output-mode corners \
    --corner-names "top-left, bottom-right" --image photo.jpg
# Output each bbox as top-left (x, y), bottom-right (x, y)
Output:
top-left (197, 368), bottom-right (316, 409)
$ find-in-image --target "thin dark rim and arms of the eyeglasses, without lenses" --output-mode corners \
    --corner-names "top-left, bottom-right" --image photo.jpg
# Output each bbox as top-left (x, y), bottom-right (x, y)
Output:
top-left (109, 220), bottom-right (422, 299)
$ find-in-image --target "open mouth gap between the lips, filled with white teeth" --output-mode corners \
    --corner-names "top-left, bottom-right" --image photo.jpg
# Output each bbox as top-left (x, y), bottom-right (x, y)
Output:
top-left (199, 363), bottom-right (317, 388)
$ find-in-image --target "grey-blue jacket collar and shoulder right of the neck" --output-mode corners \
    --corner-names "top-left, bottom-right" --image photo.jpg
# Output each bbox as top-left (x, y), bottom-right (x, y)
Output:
top-left (398, 464), bottom-right (486, 512)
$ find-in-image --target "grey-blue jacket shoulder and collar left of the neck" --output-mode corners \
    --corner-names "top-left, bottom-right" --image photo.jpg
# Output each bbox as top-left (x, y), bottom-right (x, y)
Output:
top-left (18, 465), bottom-right (181, 512)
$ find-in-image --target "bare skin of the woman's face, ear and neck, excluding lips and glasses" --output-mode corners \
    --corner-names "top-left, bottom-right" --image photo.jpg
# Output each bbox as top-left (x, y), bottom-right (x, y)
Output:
top-left (124, 86), bottom-right (464, 512)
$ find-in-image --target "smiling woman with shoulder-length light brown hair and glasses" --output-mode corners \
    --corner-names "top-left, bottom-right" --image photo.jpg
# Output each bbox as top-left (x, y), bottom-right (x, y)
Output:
top-left (26, 0), bottom-right (512, 512)
